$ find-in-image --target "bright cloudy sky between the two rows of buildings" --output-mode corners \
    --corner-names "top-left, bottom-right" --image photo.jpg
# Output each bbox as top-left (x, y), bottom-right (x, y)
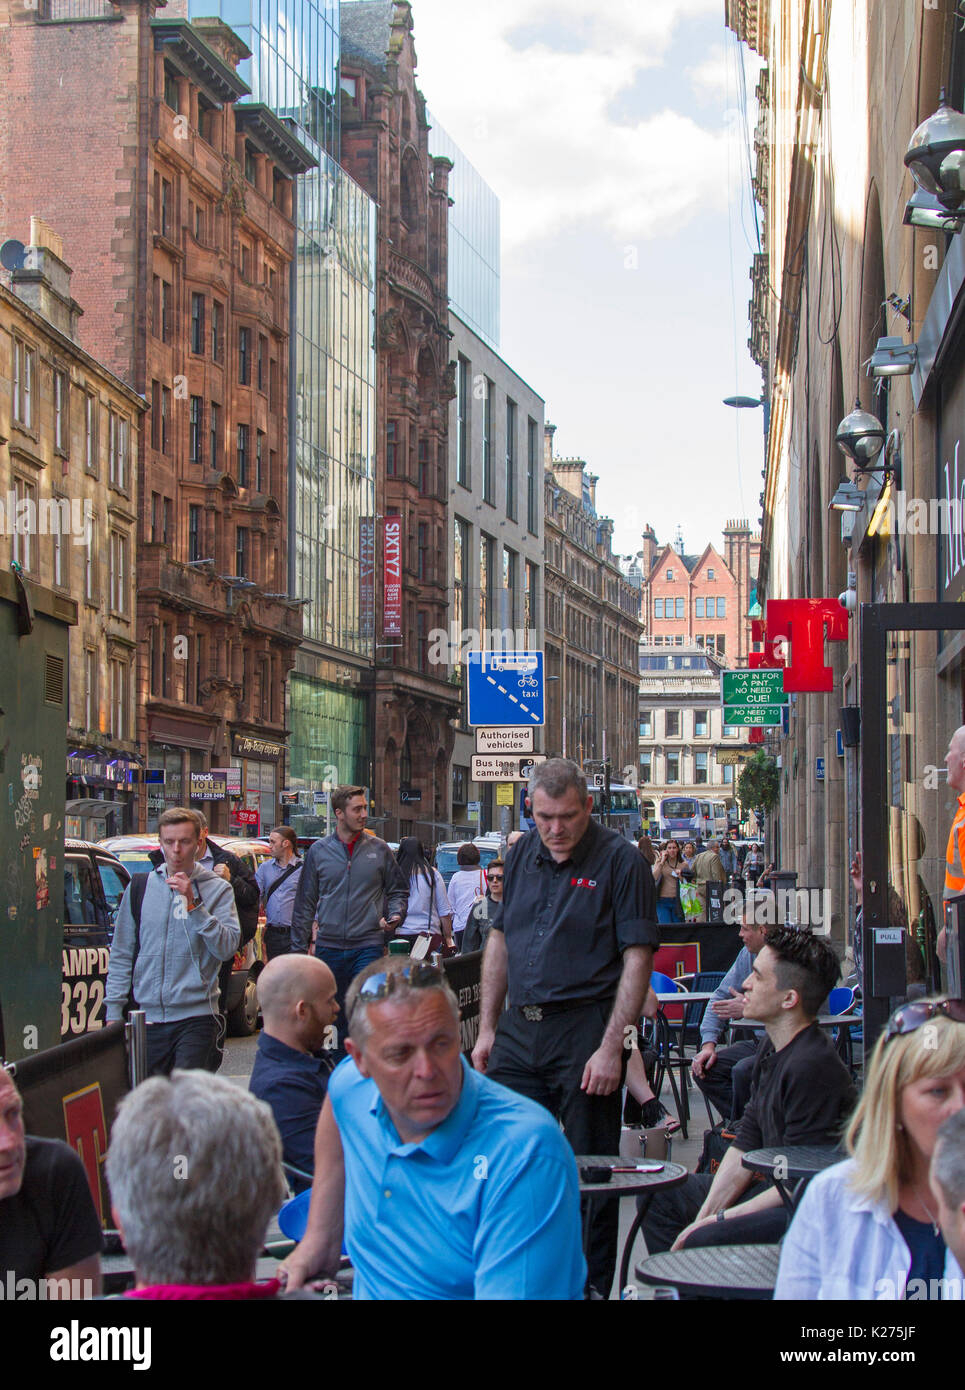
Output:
top-left (403, 0), bottom-right (763, 555)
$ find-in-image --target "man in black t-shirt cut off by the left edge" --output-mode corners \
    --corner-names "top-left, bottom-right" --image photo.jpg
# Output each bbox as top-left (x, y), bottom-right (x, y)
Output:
top-left (0, 1068), bottom-right (102, 1298)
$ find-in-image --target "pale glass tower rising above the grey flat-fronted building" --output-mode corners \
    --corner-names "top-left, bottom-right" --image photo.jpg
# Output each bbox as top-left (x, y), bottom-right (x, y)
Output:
top-left (425, 111), bottom-right (499, 352)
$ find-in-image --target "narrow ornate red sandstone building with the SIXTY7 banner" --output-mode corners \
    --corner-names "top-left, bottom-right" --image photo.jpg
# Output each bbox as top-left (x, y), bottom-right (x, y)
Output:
top-left (341, 0), bottom-right (460, 838)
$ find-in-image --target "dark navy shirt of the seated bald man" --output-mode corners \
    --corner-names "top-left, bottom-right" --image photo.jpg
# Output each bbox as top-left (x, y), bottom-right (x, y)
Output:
top-left (248, 1033), bottom-right (331, 1193)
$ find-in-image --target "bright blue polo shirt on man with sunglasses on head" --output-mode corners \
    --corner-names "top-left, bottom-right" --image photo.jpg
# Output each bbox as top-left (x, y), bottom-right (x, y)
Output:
top-left (328, 1058), bottom-right (587, 1300)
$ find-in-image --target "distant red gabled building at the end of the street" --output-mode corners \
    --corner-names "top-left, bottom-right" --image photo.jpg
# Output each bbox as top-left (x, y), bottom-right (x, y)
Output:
top-left (638, 521), bottom-right (761, 667)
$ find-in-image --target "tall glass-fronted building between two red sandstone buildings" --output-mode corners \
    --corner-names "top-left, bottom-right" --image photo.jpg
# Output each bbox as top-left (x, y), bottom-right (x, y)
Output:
top-left (189, 0), bottom-right (377, 806)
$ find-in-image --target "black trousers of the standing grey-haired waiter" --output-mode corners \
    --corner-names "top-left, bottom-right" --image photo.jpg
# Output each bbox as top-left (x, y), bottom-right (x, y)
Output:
top-left (485, 999), bottom-right (627, 1297)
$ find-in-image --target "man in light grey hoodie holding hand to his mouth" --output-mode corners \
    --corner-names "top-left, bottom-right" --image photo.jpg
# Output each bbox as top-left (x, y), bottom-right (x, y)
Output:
top-left (104, 806), bottom-right (241, 1076)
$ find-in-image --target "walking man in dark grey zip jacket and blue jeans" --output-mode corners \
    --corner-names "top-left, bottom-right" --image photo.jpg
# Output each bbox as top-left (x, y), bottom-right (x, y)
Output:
top-left (292, 787), bottom-right (409, 1052)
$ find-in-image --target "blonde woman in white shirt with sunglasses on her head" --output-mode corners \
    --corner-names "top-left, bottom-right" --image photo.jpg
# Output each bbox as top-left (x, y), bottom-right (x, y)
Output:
top-left (775, 999), bottom-right (965, 1300)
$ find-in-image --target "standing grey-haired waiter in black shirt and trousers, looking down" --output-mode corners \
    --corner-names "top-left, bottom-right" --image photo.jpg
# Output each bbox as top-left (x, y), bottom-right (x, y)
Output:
top-left (473, 758), bottom-right (659, 1298)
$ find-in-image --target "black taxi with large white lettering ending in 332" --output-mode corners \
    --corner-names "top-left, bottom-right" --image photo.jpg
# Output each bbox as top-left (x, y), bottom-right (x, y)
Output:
top-left (60, 840), bottom-right (131, 1043)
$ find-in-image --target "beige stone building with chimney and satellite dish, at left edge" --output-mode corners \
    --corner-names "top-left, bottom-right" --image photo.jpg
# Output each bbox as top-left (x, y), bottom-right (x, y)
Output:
top-left (0, 217), bottom-right (145, 835)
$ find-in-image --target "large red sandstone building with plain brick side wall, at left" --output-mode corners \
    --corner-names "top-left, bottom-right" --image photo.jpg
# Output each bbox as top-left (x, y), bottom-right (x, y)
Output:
top-left (0, 0), bottom-right (314, 831)
